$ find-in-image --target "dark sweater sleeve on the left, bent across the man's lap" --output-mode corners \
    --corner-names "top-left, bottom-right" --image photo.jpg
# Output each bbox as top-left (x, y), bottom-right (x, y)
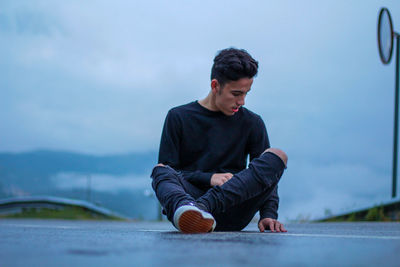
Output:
top-left (158, 109), bottom-right (213, 187)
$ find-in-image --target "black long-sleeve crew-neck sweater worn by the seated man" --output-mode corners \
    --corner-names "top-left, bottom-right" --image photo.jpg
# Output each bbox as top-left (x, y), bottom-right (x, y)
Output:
top-left (158, 101), bottom-right (279, 219)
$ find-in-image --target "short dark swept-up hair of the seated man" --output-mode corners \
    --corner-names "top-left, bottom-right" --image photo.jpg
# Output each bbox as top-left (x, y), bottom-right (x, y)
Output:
top-left (211, 48), bottom-right (258, 87)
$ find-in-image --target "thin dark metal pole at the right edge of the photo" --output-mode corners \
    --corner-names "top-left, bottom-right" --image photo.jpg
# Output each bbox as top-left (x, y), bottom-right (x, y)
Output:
top-left (392, 34), bottom-right (400, 198)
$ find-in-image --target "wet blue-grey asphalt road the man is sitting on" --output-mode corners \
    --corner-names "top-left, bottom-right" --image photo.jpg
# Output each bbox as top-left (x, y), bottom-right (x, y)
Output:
top-left (0, 219), bottom-right (400, 267)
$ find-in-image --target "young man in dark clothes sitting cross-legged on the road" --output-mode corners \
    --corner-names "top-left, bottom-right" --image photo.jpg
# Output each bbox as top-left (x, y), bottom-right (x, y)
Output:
top-left (151, 48), bottom-right (287, 233)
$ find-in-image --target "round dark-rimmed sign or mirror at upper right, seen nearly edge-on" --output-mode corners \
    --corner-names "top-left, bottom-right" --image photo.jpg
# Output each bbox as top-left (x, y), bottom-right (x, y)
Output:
top-left (378, 8), bottom-right (394, 64)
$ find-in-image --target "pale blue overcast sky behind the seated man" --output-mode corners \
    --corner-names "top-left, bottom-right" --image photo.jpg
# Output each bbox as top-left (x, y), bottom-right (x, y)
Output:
top-left (0, 0), bottom-right (400, 220)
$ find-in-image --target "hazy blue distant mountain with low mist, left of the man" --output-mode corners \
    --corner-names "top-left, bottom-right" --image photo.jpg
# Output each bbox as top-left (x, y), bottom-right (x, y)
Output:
top-left (0, 150), bottom-right (157, 219)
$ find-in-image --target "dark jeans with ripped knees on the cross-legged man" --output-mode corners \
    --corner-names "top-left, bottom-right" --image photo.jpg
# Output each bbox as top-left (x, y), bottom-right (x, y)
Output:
top-left (151, 152), bottom-right (285, 231)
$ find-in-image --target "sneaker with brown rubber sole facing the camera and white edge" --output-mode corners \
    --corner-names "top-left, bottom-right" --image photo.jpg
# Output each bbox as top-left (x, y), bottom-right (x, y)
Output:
top-left (174, 205), bottom-right (216, 234)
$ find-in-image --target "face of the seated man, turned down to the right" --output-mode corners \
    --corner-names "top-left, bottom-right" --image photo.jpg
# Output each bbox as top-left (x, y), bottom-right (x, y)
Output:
top-left (213, 78), bottom-right (253, 116)
